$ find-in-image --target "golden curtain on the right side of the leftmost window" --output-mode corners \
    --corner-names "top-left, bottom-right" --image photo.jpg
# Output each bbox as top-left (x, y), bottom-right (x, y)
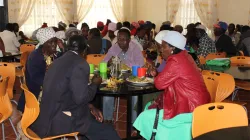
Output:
top-left (55, 0), bottom-right (74, 24)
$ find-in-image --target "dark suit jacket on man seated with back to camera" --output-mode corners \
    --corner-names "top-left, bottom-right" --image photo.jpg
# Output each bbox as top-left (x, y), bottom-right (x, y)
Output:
top-left (31, 51), bottom-right (97, 138)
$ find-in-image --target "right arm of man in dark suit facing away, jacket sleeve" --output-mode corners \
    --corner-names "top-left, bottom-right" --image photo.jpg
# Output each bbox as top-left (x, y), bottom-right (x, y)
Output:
top-left (70, 63), bottom-right (98, 105)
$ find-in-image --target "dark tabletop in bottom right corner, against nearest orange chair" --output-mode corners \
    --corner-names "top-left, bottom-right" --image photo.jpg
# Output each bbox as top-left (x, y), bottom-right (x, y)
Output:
top-left (193, 126), bottom-right (250, 140)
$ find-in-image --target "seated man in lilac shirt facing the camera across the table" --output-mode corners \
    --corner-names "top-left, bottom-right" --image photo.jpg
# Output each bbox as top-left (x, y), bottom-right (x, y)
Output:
top-left (103, 29), bottom-right (144, 121)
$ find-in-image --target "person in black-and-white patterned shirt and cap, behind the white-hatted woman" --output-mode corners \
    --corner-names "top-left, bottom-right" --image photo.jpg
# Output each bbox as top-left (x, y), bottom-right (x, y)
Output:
top-left (196, 25), bottom-right (216, 57)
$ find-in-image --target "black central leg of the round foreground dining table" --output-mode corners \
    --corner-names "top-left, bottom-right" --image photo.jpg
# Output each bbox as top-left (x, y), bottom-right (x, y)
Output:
top-left (126, 94), bottom-right (132, 139)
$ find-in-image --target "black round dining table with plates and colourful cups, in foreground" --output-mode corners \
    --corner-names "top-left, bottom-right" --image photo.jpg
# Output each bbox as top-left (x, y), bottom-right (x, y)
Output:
top-left (96, 74), bottom-right (162, 140)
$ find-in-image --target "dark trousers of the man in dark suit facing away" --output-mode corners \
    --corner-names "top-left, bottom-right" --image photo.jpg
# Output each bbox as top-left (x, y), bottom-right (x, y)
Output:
top-left (81, 120), bottom-right (121, 140)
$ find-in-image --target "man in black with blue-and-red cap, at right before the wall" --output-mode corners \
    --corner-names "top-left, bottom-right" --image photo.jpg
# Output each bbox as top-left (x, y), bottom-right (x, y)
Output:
top-left (214, 21), bottom-right (237, 56)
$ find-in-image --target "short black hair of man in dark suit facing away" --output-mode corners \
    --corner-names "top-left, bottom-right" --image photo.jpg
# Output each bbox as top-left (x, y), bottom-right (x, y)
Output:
top-left (67, 35), bottom-right (88, 54)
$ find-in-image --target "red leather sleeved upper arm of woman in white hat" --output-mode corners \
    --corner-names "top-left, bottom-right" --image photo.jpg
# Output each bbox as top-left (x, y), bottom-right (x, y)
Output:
top-left (155, 60), bottom-right (179, 90)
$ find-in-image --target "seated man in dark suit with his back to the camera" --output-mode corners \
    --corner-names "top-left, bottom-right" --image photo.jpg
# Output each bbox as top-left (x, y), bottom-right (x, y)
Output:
top-left (31, 35), bottom-right (120, 140)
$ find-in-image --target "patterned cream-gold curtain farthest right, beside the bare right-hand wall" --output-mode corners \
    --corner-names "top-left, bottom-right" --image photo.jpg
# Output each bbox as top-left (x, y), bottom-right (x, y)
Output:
top-left (194, 0), bottom-right (219, 30)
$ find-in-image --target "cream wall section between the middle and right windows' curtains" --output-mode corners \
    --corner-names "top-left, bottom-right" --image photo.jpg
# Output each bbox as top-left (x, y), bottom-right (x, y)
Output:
top-left (136, 0), bottom-right (167, 29)
